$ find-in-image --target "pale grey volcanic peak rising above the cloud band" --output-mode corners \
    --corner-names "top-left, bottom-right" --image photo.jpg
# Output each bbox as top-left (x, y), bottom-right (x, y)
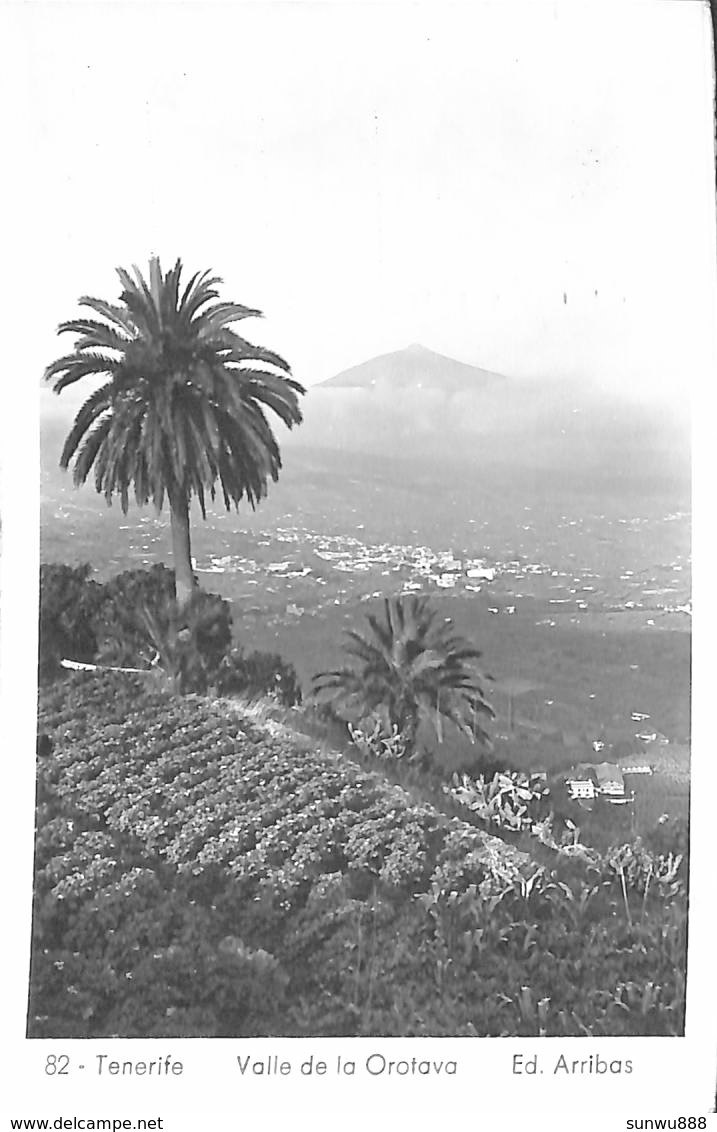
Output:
top-left (315, 342), bottom-right (506, 393)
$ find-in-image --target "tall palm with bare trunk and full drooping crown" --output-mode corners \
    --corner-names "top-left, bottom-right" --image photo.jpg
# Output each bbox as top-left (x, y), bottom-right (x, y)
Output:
top-left (44, 257), bottom-right (304, 608)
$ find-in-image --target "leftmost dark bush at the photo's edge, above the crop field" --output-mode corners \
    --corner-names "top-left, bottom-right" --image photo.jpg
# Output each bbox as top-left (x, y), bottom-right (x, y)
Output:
top-left (40, 563), bottom-right (102, 681)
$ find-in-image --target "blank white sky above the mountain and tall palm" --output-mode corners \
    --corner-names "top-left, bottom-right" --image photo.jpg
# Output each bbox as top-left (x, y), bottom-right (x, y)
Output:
top-left (5, 0), bottom-right (715, 416)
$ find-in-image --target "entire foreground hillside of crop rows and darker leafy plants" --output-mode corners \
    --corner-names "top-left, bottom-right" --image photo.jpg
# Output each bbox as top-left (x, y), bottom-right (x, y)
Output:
top-left (28, 674), bottom-right (686, 1037)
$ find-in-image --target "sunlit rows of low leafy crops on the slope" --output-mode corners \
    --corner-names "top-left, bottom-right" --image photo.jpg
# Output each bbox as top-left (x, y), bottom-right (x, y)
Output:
top-left (36, 670), bottom-right (522, 892)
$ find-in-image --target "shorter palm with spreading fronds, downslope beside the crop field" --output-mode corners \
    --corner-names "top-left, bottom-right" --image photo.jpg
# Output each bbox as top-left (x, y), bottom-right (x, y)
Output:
top-left (314, 594), bottom-right (494, 749)
